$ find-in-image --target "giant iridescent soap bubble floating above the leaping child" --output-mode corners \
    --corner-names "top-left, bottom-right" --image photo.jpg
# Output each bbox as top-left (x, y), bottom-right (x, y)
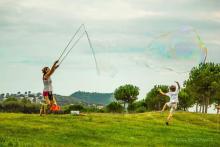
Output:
top-left (145, 27), bottom-right (207, 73)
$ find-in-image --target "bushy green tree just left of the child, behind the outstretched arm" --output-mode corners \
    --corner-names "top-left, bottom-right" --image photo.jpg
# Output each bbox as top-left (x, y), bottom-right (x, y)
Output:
top-left (145, 85), bottom-right (169, 110)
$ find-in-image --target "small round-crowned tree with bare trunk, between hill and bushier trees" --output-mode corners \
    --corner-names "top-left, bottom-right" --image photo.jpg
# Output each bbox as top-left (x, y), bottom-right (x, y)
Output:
top-left (114, 84), bottom-right (139, 108)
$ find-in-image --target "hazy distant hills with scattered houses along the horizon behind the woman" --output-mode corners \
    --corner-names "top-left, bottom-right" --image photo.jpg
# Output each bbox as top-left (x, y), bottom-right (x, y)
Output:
top-left (0, 91), bottom-right (114, 109)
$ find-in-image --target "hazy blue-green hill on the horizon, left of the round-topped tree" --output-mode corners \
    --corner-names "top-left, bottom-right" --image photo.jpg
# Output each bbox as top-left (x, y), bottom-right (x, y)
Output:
top-left (70, 91), bottom-right (114, 105)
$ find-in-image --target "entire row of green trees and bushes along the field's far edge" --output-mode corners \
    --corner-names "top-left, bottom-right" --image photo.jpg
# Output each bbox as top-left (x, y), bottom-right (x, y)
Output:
top-left (0, 63), bottom-right (220, 113)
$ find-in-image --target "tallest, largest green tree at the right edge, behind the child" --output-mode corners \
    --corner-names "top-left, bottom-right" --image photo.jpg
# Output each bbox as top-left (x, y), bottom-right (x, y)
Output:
top-left (184, 63), bottom-right (220, 113)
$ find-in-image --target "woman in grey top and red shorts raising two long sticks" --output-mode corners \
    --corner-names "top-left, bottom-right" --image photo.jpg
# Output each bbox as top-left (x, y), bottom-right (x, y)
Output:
top-left (40, 60), bottom-right (59, 115)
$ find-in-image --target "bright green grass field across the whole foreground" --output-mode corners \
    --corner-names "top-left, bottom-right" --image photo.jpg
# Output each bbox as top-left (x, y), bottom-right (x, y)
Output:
top-left (0, 112), bottom-right (220, 147)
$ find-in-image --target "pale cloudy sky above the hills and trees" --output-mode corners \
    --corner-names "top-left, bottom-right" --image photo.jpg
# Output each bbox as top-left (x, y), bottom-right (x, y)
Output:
top-left (0, 0), bottom-right (220, 99)
